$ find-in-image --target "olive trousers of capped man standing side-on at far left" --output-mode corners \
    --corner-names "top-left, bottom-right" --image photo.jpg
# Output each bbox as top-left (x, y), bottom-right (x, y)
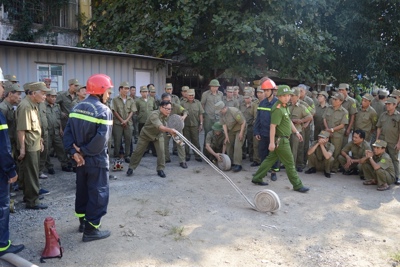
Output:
top-left (22, 150), bottom-right (40, 207)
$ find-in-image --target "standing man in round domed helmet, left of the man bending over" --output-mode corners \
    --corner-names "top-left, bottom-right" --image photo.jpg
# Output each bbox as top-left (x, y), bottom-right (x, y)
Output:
top-left (200, 79), bottom-right (223, 151)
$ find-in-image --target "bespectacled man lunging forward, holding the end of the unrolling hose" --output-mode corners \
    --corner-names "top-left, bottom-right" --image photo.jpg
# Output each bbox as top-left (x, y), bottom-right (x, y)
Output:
top-left (126, 100), bottom-right (175, 178)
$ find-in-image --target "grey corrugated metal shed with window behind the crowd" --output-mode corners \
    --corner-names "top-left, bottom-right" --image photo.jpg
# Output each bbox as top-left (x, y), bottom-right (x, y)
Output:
top-left (0, 40), bottom-right (171, 95)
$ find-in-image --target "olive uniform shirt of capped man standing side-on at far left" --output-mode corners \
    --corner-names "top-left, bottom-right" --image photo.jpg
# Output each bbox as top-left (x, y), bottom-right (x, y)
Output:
top-left (17, 96), bottom-right (42, 152)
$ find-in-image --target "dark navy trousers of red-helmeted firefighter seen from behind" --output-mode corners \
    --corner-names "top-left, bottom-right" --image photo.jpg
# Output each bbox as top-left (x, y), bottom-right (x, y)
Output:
top-left (75, 166), bottom-right (109, 226)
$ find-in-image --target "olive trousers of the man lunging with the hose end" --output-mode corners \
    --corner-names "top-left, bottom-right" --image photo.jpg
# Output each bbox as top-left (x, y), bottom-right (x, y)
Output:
top-left (129, 134), bottom-right (165, 171)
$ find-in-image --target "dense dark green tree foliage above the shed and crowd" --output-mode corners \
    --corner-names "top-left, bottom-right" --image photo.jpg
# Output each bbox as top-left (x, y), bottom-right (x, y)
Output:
top-left (80, 0), bottom-right (400, 87)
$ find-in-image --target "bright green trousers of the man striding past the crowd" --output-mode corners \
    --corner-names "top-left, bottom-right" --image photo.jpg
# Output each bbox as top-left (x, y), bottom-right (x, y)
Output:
top-left (253, 138), bottom-right (303, 190)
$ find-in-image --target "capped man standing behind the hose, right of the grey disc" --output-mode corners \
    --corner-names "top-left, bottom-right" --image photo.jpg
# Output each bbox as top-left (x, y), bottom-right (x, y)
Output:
top-left (181, 89), bottom-right (204, 162)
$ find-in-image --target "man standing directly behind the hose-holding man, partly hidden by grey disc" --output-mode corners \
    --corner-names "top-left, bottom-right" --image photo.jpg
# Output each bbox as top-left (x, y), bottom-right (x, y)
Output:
top-left (161, 93), bottom-right (188, 169)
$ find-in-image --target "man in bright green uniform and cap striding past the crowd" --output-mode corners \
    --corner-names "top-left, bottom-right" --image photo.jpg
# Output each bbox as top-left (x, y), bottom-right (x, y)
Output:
top-left (252, 85), bottom-right (309, 193)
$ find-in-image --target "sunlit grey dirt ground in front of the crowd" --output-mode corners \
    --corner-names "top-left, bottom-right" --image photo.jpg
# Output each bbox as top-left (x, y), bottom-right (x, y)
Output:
top-left (0, 146), bottom-right (400, 267)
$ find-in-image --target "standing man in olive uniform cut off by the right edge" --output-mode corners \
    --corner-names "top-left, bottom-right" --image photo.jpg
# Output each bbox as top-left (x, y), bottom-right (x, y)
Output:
top-left (376, 98), bottom-right (400, 185)
